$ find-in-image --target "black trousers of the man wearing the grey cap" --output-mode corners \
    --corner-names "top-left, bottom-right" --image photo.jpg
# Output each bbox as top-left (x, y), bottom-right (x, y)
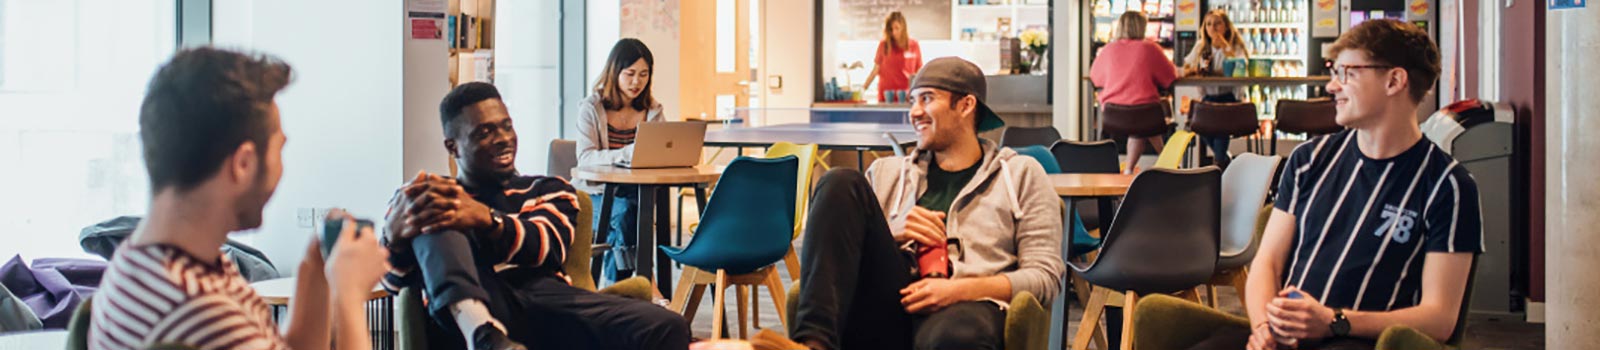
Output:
top-left (789, 169), bottom-right (1005, 348)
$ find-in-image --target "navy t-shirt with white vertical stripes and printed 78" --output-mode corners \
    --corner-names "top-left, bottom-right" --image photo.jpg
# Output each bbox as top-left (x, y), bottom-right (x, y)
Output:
top-left (1274, 131), bottom-right (1483, 312)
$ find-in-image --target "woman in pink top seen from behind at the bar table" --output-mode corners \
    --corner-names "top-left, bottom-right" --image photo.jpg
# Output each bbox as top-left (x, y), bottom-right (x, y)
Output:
top-left (1090, 11), bottom-right (1178, 173)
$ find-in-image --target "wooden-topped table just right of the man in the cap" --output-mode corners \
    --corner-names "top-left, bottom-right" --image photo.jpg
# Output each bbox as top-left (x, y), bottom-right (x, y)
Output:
top-left (1050, 174), bottom-right (1134, 348)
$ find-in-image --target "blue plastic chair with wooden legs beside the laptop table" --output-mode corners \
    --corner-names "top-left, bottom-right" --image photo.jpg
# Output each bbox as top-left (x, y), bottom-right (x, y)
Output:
top-left (661, 155), bottom-right (800, 339)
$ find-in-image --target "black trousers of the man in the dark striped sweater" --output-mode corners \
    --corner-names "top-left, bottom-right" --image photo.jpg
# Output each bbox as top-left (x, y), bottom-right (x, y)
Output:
top-left (411, 232), bottom-right (690, 348)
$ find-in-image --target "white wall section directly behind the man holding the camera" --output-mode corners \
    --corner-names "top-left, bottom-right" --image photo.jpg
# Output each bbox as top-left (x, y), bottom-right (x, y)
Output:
top-left (213, 0), bottom-right (408, 273)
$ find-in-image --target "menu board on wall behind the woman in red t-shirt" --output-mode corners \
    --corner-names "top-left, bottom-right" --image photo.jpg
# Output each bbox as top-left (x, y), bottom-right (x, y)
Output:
top-left (838, 0), bottom-right (950, 40)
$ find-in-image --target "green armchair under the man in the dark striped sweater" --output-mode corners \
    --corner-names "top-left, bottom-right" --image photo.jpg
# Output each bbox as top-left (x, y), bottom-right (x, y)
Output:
top-left (395, 190), bottom-right (654, 350)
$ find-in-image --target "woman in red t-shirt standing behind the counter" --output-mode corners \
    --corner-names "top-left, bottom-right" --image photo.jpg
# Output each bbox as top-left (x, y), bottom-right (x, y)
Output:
top-left (861, 11), bottom-right (922, 102)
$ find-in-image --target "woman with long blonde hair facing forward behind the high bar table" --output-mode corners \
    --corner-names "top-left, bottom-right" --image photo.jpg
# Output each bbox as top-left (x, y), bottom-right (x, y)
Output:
top-left (1182, 10), bottom-right (1250, 166)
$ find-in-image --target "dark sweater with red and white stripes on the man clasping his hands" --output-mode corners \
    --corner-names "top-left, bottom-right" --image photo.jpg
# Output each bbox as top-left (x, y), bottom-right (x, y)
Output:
top-left (382, 176), bottom-right (578, 292)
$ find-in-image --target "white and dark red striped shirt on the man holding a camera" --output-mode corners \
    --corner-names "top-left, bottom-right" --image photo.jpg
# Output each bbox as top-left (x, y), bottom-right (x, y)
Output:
top-left (88, 245), bottom-right (288, 350)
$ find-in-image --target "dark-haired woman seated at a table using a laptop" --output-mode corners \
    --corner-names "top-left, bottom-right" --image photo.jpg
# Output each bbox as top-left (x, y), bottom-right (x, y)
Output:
top-left (573, 38), bottom-right (664, 283)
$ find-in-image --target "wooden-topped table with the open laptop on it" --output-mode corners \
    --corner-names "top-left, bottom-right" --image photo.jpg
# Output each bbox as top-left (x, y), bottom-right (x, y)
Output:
top-left (573, 165), bottom-right (723, 296)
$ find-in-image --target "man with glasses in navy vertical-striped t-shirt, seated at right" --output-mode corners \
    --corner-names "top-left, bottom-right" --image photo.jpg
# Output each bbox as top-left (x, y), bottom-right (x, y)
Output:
top-left (1141, 21), bottom-right (1483, 350)
